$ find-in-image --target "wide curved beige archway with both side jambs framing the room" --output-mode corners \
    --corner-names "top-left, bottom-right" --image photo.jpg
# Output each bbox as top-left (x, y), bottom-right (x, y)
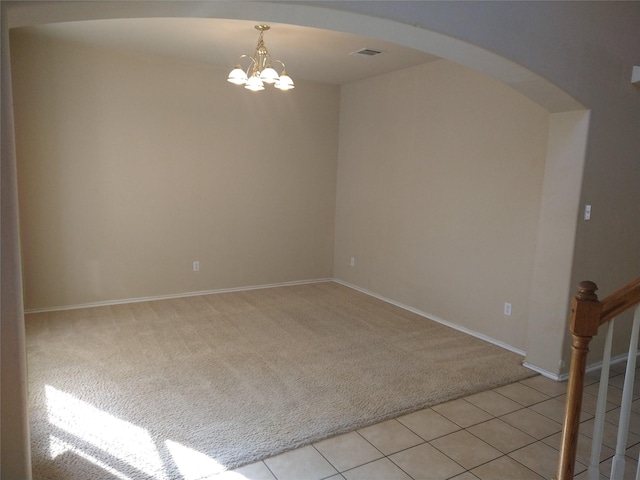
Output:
top-left (2, 2), bottom-right (586, 477)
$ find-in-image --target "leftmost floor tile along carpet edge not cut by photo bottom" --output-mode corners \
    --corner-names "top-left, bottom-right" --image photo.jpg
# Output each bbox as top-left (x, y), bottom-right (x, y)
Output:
top-left (314, 432), bottom-right (383, 472)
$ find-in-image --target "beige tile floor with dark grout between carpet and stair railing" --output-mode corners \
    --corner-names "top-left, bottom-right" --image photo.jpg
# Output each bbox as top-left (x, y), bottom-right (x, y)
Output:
top-left (219, 366), bottom-right (640, 480)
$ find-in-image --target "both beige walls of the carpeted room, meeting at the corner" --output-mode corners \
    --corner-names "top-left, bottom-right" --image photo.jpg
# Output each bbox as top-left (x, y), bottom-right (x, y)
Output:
top-left (12, 34), bottom-right (550, 350)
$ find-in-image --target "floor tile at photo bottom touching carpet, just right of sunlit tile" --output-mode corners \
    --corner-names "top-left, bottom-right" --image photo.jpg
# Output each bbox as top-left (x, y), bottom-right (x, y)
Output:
top-left (264, 445), bottom-right (338, 480)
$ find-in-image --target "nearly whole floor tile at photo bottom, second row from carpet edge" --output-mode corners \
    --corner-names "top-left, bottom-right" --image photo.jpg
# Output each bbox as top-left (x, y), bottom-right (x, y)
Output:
top-left (389, 443), bottom-right (465, 480)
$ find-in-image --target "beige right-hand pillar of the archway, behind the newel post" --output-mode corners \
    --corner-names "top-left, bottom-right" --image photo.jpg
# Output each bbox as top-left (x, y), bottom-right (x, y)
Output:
top-left (526, 111), bottom-right (590, 374)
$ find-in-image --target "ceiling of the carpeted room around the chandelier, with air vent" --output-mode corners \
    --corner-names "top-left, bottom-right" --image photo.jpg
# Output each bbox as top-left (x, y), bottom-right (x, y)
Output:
top-left (15, 18), bottom-right (438, 85)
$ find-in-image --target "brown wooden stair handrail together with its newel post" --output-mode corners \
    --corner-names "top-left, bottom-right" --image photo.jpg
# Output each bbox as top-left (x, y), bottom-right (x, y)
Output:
top-left (555, 278), bottom-right (640, 480)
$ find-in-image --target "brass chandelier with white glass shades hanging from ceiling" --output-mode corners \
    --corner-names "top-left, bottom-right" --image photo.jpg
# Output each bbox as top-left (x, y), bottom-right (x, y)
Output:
top-left (227, 24), bottom-right (294, 92)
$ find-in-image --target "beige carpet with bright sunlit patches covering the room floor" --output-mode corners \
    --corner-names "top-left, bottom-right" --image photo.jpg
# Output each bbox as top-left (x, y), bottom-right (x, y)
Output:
top-left (26, 283), bottom-right (533, 480)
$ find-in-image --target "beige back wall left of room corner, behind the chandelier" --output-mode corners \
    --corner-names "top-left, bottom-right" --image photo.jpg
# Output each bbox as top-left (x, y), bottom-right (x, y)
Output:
top-left (12, 34), bottom-right (339, 309)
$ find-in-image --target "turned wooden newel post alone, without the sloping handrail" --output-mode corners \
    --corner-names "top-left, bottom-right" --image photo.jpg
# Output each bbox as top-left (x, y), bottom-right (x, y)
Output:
top-left (556, 281), bottom-right (602, 480)
